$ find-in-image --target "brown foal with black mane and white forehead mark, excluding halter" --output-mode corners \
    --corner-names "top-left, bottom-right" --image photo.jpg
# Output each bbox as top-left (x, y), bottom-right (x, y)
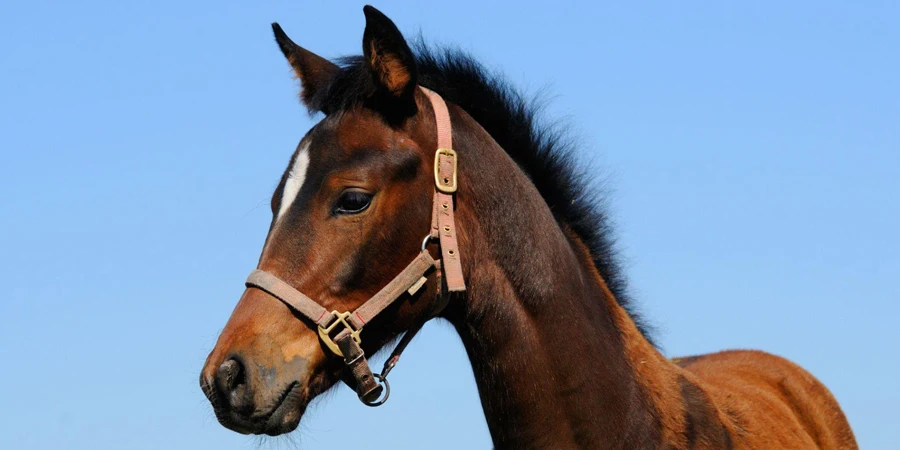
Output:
top-left (200, 7), bottom-right (857, 449)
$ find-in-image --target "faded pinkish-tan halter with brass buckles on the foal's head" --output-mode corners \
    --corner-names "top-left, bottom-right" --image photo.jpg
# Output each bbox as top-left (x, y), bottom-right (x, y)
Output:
top-left (246, 86), bottom-right (466, 406)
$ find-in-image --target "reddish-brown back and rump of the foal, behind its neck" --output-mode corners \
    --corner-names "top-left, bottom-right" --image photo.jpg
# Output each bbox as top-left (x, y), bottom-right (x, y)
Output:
top-left (673, 350), bottom-right (859, 449)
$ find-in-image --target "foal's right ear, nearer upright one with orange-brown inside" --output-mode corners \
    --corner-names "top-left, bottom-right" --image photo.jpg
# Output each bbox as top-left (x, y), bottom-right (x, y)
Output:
top-left (363, 5), bottom-right (416, 108)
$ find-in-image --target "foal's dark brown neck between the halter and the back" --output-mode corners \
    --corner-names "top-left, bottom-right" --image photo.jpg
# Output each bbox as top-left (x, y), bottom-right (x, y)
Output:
top-left (446, 108), bottom-right (684, 448)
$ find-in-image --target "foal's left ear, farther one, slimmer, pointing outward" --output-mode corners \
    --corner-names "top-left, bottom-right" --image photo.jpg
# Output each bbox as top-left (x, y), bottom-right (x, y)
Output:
top-left (272, 22), bottom-right (339, 109)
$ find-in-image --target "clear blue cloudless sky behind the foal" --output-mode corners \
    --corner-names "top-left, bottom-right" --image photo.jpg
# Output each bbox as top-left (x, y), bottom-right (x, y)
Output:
top-left (0, 0), bottom-right (900, 449)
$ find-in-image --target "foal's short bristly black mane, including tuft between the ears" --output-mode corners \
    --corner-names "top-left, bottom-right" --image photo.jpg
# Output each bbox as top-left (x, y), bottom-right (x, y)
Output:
top-left (308, 41), bottom-right (652, 342)
